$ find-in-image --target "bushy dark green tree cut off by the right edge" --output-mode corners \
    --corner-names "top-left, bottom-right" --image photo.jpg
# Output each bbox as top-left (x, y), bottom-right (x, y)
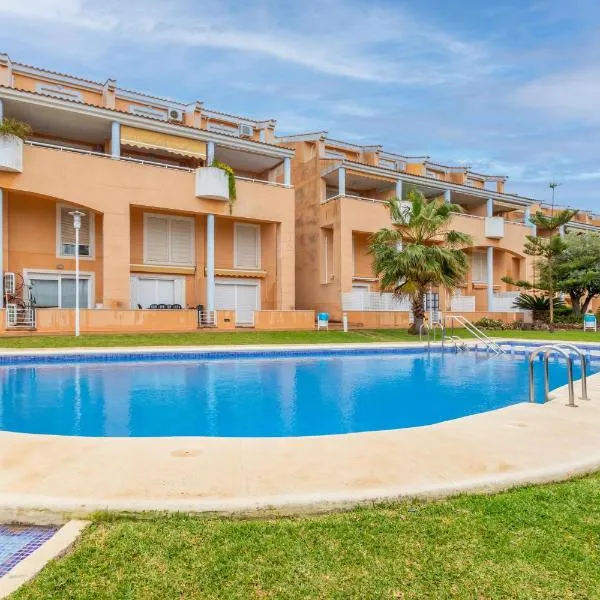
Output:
top-left (542, 233), bottom-right (600, 317)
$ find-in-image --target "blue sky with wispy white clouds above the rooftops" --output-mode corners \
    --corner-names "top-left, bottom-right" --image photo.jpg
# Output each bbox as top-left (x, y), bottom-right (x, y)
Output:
top-left (0, 0), bottom-right (600, 212)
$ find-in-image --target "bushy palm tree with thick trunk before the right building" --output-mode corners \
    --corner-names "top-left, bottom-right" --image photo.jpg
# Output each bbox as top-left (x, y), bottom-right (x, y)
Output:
top-left (369, 189), bottom-right (471, 333)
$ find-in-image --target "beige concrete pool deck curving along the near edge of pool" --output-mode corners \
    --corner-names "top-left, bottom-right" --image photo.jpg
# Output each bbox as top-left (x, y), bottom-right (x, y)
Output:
top-left (0, 340), bottom-right (600, 523)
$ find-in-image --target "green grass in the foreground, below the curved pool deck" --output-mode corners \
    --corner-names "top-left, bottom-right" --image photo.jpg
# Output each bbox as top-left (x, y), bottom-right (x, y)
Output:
top-left (14, 474), bottom-right (600, 600)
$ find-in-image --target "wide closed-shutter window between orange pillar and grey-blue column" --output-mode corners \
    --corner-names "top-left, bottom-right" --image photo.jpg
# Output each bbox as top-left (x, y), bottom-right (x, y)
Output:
top-left (144, 213), bottom-right (195, 266)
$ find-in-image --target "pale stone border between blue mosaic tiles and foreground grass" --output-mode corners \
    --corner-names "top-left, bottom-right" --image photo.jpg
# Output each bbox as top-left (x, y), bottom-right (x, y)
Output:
top-left (0, 520), bottom-right (89, 598)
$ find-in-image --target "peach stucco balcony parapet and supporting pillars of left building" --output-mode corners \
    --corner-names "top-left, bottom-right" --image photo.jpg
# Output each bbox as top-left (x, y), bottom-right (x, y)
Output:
top-left (0, 146), bottom-right (295, 310)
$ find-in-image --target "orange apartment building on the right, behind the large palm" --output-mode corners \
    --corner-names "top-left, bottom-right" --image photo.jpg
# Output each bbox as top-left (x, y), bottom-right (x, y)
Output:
top-left (277, 132), bottom-right (552, 326)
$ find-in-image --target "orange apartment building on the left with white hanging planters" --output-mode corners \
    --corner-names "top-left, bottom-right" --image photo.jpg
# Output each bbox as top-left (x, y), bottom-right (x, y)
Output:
top-left (0, 55), bottom-right (312, 330)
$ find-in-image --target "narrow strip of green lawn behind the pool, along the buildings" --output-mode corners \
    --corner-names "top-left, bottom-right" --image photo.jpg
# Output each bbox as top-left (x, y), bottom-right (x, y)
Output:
top-left (0, 329), bottom-right (600, 348)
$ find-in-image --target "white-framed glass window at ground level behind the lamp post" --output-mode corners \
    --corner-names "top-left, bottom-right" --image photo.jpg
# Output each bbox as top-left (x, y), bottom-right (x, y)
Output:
top-left (25, 271), bottom-right (93, 308)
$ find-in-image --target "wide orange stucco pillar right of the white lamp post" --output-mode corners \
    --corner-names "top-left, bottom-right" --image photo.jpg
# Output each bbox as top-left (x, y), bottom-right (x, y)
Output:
top-left (102, 209), bottom-right (131, 310)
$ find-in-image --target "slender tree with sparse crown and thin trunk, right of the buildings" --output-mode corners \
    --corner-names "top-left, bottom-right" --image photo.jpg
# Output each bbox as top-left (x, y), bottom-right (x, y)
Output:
top-left (523, 208), bottom-right (579, 331)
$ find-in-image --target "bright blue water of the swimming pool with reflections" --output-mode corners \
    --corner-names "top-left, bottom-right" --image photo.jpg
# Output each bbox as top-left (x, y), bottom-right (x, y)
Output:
top-left (0, 350), bottom-right (598, 437)
